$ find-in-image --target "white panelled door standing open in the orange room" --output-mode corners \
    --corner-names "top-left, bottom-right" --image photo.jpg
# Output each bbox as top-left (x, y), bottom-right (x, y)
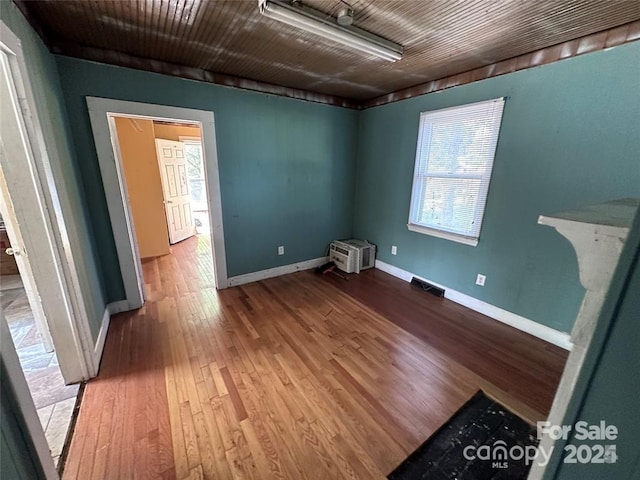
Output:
top-left (156, 139), bottom-right (196, 245)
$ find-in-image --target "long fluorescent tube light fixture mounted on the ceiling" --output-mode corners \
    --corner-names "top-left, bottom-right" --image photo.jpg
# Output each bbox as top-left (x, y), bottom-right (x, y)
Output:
top-left (258, 0), bottom-right (402, 62)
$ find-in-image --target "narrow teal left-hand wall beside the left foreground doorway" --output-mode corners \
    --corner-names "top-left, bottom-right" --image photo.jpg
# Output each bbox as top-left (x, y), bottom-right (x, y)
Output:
top-left (0, 0), bottom-right (106, 340)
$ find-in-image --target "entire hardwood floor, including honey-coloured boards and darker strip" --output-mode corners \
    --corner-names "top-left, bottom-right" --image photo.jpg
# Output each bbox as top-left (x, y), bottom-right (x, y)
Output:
top-left (64, 237), bottom-right (565, 480)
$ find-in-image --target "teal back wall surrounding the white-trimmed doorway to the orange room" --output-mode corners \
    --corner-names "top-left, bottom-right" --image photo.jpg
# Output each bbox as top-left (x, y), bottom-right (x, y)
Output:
top-left (56, 57), bottom-right (358, 301)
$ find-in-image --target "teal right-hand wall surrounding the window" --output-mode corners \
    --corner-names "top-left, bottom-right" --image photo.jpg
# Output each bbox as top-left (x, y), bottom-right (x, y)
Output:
top-left (353, 42), bottom-right (640, 332)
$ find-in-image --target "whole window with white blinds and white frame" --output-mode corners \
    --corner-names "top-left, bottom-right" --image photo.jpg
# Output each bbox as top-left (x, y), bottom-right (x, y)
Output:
top-left (407, 98), bottom-right (504, 246)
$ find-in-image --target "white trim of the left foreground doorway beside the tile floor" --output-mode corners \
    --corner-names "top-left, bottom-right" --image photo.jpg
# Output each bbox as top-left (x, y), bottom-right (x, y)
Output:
top-left (0, 21), bottom-right (98, 384)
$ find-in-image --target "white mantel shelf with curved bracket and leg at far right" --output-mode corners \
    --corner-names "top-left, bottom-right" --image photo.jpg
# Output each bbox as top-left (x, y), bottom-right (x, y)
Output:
top-left (529, 198), bottom-right (640, 480)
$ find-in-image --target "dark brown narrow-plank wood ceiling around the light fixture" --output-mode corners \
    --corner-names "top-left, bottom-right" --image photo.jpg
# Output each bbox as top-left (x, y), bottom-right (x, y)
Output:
top-left (16, 0), bottom-right (640, 103)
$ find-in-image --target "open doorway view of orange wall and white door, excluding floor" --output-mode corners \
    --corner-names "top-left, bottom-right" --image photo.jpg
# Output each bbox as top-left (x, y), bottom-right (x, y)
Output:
top-left (107, 114), bottom-right (215, 286)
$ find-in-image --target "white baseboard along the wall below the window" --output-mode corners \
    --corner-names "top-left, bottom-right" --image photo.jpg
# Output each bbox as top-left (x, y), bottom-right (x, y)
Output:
top-left (376, 260), bottom-right (573, 350)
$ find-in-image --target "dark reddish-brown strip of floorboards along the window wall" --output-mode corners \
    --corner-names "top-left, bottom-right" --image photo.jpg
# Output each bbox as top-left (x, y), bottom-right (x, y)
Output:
top-left (326, 269), bottom-right (568, 422)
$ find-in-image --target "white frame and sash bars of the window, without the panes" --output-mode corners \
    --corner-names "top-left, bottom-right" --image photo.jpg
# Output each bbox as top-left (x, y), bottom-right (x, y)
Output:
top-left (407, 97), bottom-right (506, 247)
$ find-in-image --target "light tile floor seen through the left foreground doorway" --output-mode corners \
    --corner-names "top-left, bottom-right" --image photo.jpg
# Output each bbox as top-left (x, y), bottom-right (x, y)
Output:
top-left (0, 275), bottom-right (79, 466)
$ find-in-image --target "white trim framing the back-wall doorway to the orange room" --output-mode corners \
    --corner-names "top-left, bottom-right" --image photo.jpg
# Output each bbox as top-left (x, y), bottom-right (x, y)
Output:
top-left (87, 97), bottom-right (228, 309)
